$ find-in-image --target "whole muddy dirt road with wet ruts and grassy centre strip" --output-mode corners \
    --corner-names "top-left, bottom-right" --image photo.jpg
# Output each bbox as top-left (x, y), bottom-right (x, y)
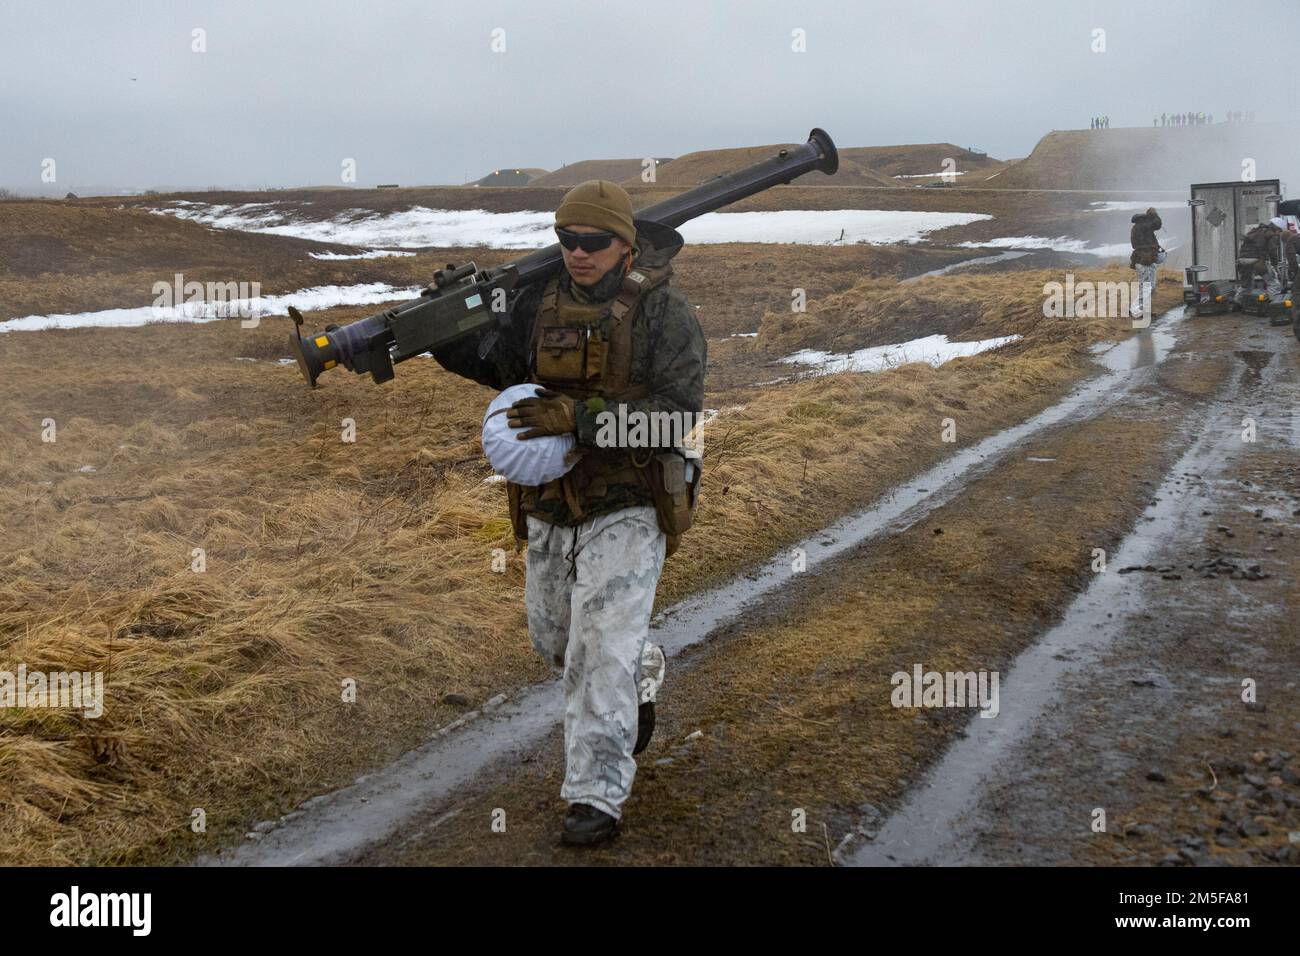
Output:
top-left (207, 306), bottom-right (1300, 865)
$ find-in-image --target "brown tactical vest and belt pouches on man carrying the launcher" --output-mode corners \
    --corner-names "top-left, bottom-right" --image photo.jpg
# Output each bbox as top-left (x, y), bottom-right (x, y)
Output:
top-left (507, 263), bottom-right (698, 553)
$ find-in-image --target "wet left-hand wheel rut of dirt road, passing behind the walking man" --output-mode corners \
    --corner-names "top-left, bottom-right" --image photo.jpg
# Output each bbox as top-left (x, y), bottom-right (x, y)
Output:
top-left (210, 308), bottom-right (1182, 866)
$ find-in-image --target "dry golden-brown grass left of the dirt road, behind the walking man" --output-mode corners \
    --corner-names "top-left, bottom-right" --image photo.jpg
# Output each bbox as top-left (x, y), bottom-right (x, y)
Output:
top-left (0, 251), bottom-right (1159, 864)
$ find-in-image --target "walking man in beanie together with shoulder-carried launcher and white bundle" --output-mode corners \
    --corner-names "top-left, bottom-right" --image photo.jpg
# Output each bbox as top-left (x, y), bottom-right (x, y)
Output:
top-left (289, 129), bottom-right (839, 843)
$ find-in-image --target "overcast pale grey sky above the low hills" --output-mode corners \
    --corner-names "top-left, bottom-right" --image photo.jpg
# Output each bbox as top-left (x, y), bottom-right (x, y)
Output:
top-left (0, 0), bottom-right (1300, 191)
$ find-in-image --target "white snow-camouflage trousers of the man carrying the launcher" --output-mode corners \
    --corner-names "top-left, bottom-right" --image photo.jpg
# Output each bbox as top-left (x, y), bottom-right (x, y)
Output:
top-left (524, 506), bottom-right (667, 817)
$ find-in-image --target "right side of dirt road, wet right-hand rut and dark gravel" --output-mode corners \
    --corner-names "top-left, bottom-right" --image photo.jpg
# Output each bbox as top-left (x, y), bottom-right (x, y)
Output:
top-left (845, 329), bottom-right (1300, 865)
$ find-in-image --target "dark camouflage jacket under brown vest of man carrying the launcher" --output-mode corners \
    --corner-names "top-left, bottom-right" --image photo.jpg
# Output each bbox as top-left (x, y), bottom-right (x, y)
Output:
top-left (433, 220), bottom-right (707, 525)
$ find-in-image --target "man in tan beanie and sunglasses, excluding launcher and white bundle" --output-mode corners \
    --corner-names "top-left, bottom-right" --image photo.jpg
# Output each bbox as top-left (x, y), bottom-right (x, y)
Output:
top-left (433, 179), bottom-right (706, 843)
